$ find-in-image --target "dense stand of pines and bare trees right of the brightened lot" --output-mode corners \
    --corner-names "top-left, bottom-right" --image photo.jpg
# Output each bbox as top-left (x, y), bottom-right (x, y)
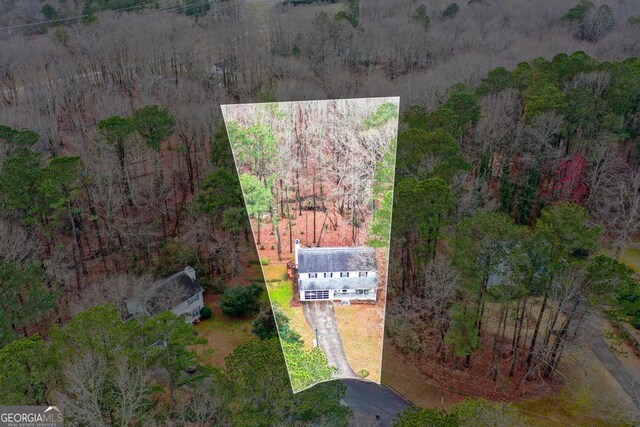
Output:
top-left (388, 53), bottom-right (640, 412)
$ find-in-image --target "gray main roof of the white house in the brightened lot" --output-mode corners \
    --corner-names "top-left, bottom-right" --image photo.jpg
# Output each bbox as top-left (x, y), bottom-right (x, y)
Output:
top-left (298, 247), bottom-right (376, 273)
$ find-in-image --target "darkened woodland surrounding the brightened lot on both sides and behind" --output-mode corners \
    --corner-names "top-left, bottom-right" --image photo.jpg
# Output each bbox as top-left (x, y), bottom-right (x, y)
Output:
top-left (0, 0), bottom-right (640, 425)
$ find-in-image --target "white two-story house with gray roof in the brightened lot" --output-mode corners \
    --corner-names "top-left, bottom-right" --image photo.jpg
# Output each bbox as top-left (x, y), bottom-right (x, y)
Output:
top-left (295, 240), bottom-right (378, 301)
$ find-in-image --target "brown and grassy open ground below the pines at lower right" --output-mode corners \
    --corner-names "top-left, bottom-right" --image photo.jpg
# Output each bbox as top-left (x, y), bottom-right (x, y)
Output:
top-left (383, 312), bottom-right (634, 427)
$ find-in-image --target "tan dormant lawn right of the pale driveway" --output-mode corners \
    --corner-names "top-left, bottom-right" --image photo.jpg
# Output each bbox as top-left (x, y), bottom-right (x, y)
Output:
top-left (333, 304), bottom-right (383, 382)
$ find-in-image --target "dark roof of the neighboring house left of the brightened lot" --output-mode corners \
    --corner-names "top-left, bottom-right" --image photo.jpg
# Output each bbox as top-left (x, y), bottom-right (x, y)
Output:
top-left (134, 271), bottom-right (204, 316)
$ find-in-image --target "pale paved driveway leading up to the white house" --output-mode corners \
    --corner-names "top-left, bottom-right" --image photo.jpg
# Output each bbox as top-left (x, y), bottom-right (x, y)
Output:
top-left (302, 301), bottom-right (358, 378)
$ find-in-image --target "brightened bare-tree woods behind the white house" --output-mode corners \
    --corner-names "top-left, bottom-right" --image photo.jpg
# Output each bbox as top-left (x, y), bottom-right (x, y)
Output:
top-left (223, 98), bottom-right (398, 256)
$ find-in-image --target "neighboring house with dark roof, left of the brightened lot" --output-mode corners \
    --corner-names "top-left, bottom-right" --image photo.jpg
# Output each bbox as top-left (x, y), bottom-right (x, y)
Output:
top-left (127, 267), bottom-right (204, 323)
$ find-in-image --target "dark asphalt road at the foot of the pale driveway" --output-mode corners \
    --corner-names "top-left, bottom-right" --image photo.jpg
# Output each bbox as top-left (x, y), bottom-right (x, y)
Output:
top-left (341, 379), bottom-right (412, 426)
